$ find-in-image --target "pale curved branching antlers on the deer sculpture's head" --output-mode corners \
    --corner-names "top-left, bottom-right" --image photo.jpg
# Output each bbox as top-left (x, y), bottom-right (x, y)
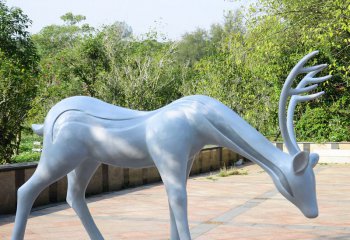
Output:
top-left (278, 51), bottom-right (332, 155)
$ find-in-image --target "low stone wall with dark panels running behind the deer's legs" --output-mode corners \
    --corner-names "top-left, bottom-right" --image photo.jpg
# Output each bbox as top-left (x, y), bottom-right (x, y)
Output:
top-left (0, 143), bottom-right (350, 214)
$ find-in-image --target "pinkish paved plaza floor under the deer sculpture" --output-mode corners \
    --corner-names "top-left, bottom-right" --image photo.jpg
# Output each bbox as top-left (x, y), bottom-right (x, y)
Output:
top-left (0, 164), bottom-right (350, 240)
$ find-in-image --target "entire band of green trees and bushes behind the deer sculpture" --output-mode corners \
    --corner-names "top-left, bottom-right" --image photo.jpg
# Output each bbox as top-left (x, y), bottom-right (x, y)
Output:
top-left (6, 0), bottom-right (350, 164)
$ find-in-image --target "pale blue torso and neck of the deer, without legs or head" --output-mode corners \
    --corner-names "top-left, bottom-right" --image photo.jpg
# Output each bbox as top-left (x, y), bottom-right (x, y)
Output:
top-left (39, 96), bottom-right (288, 171)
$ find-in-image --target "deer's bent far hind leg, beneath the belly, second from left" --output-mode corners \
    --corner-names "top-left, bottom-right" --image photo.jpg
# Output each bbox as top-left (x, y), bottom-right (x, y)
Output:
top-left (67, 161), bottom-right (103, 240)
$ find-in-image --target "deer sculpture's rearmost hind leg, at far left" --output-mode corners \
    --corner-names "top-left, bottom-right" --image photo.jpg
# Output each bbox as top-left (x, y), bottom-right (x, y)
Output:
top-left (11, 153), bottom-right (82, 240)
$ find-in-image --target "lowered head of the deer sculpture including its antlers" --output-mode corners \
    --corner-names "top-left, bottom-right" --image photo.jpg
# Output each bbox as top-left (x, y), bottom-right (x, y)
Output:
top-left (276, 51), bottom-right (331, 218)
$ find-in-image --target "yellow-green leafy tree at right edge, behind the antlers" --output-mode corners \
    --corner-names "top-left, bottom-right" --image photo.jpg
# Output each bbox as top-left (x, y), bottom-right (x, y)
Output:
top-left (246, 0), bottom-right (350, 141)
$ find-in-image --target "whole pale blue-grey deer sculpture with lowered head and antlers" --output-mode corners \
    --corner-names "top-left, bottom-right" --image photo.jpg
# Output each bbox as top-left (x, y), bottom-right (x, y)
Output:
top-left (12, 51), bottom-right (331, 240)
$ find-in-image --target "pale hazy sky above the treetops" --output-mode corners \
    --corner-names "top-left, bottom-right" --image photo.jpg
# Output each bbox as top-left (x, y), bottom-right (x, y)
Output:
top-left (6, 0), bottom-right (251, 40)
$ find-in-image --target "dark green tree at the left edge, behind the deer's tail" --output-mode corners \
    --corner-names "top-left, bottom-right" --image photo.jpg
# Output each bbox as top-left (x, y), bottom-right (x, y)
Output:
top-left (0, 2), bottom-right (39, 162)
